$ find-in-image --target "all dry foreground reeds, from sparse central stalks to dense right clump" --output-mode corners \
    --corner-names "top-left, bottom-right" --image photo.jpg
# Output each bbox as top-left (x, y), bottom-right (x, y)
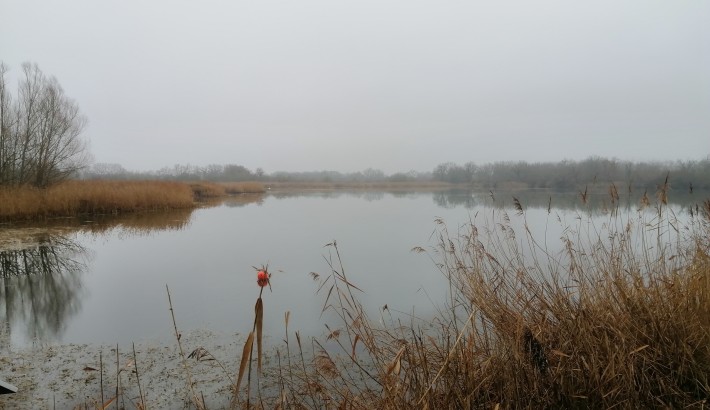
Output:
top-left (224, 192), bottom-right (710, 409)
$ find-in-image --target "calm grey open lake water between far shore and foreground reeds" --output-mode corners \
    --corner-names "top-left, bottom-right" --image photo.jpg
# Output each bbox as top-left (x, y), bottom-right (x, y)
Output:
top-left (0, 187), bottom-right (707, 348)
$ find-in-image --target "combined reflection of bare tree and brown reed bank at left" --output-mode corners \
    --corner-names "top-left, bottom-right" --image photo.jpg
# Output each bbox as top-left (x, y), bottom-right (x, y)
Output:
top-left (0, 209), bottom-right (193, 346)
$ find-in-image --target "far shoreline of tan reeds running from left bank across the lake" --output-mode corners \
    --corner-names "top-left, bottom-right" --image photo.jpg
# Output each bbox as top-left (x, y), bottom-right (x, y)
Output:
top-left (0, 180), bottom-right (702, 227)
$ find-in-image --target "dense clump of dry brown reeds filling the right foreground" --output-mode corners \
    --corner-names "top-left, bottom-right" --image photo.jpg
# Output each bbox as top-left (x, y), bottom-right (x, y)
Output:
top-left (410, 200), bottom-right (710, 408)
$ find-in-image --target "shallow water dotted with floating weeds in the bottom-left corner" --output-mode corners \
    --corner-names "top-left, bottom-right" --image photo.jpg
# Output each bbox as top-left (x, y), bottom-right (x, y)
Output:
top-left (0, 329), bottom-right (268, 409)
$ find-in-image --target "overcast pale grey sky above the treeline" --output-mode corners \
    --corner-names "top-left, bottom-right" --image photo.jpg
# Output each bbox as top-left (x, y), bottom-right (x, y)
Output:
top-left (0, 0), bottom-right (710, 173)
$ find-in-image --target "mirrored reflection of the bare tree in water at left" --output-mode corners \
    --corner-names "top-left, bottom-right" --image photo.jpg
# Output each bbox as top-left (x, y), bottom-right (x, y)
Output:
top-left (0, 235), bottom-right (87, 340)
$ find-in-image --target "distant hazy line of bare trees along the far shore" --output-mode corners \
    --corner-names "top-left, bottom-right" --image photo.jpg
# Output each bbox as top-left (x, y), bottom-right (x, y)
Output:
top-left (82, 156), bottom-right (710, 190)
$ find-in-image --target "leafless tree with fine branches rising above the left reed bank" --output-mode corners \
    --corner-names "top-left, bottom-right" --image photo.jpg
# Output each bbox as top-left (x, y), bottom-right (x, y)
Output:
top-left (0, 63), bottom-right (88, 187)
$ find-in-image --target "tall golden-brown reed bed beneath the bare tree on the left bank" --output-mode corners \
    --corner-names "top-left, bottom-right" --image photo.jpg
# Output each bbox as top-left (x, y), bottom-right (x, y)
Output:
top-left (0, 181), bottom-right (194, 220)
